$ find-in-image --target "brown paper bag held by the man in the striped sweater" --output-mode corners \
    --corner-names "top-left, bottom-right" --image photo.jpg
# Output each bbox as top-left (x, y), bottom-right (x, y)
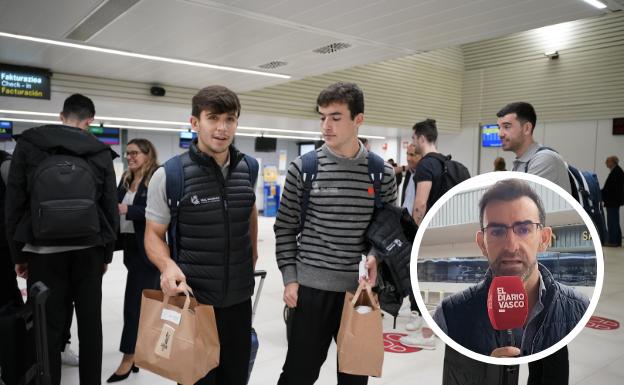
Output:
top-left (336, 283), bottom-right (384, 377)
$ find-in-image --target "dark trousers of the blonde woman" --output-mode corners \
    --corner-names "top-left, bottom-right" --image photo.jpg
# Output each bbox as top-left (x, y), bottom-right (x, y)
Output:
top-left (119, 234), bottom-right (160, 354)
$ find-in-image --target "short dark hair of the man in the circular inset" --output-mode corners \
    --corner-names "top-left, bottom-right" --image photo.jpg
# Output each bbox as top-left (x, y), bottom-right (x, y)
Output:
top-left (479, 179), bottom-right (546, 228)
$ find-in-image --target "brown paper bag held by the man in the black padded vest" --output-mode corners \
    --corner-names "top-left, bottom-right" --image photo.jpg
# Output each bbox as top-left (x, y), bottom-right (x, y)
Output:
top-left (134, 290), bottom-right (220, 385)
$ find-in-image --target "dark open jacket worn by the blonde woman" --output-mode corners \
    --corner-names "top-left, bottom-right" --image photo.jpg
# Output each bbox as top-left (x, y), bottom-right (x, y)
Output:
top-left (116, 174), bottom-right (158, 271)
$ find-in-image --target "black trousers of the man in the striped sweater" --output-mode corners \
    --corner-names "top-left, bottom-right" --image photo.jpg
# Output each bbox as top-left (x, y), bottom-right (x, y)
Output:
top-left (278, 286), bottom-right (368, 385)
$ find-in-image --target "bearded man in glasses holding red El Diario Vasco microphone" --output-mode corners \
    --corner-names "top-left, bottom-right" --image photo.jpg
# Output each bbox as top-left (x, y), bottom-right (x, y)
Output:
top-left (434, 179), bottom-right (589, 384)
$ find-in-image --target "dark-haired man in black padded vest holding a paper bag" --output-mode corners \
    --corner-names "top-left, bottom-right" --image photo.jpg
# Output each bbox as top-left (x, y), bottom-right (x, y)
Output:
top-left (145, 86), bottom-right (258, 385)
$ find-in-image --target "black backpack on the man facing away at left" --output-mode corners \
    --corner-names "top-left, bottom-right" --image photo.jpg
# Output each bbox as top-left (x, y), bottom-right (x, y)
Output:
top-left (30, 153), bottom-right (100, 238)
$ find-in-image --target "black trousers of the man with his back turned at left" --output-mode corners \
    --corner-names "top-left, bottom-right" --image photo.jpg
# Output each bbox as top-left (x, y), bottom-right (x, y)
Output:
top-left (28, 247), bottom-right (104, 385)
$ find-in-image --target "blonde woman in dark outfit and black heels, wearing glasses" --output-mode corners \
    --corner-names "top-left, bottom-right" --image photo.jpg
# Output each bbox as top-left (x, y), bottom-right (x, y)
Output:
top-left (107, 139), bottom-right (160, 382)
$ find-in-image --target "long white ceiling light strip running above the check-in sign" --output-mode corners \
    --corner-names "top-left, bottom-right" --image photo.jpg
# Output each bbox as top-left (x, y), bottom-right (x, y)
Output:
top-left (0, 32), bottom-right (290, 79)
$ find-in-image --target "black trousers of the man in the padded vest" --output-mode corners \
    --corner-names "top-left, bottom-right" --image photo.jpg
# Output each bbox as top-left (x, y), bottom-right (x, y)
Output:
top-left (196, 299), bottom-right (251, 385)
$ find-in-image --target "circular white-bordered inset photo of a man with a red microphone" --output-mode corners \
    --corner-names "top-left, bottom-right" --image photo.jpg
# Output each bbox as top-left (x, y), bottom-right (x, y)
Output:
top-left (410, 172), bottom-right (603, 365)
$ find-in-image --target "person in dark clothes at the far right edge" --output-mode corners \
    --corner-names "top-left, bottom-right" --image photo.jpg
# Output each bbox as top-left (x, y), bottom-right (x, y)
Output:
top-left (602, 155), bottom-right (624, 247)
